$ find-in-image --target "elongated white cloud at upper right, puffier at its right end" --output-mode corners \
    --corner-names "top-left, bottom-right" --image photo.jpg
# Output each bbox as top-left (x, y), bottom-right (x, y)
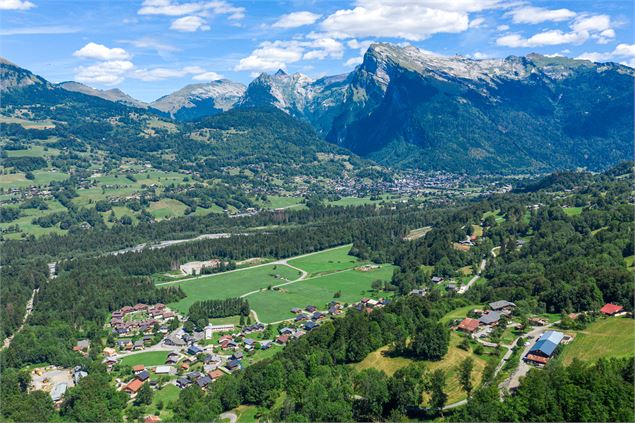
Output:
top-left (496, 15), bottom-right (615, 48)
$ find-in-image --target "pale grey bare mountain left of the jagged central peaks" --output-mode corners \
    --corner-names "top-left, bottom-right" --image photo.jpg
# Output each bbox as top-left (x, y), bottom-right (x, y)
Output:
top-left (150, 79), bottom-right (245, 120)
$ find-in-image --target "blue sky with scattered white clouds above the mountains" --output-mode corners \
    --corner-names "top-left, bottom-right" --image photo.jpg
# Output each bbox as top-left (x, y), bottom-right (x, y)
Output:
top-left (0, 0), bottom-right (635, 101)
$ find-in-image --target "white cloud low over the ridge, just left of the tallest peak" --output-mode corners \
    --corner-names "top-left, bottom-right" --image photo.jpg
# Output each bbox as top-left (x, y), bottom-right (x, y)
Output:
top-left (234, 34), bottom-right (344, 72)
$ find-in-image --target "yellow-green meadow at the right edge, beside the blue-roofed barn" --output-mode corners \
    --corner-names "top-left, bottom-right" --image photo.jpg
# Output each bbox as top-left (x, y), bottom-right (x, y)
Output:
top-left (558, 317), bottom-right (635, 364)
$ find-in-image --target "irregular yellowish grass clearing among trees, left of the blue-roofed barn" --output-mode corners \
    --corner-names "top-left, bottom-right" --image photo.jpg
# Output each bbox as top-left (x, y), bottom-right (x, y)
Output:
top-left (352, 332), bottom-right (495, 404)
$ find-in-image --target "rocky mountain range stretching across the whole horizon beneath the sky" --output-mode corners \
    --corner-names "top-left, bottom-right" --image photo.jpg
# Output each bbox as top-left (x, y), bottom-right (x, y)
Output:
top-left (0, 44), bottom-right (635, 173)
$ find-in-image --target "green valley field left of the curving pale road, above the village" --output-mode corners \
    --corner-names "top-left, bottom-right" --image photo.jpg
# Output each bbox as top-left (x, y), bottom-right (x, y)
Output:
top-left (170, 265), bottom-right (300, 313)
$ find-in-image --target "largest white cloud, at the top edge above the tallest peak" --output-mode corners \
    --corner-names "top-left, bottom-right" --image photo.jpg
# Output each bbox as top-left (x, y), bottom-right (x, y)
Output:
top-left (321, 0), bottom-right (498, 41)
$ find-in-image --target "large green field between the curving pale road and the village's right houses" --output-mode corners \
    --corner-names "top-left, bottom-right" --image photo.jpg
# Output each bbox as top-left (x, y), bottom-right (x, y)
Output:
top-left (247, 264), bottom-right (393, 322)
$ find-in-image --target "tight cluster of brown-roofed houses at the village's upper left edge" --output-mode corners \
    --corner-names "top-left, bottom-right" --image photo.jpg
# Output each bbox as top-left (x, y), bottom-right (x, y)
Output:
top-left (110, 304), bottom-right (176, 335)
